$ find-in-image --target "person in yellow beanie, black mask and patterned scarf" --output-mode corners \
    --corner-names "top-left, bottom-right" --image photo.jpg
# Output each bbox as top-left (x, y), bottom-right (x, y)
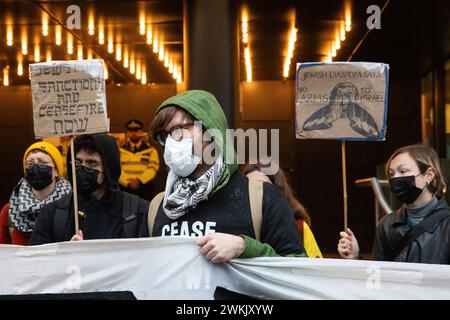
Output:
top-left (0, 142), bottom-right (72, 245)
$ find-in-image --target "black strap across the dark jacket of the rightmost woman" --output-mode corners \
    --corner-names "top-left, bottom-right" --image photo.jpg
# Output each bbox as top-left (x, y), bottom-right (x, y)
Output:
top-left (390, 210), bottom-right (450, 261)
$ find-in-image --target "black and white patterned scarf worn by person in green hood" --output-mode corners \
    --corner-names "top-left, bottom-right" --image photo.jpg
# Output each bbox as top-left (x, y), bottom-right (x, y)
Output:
top-left (163, 154), bottom-right (225, 219)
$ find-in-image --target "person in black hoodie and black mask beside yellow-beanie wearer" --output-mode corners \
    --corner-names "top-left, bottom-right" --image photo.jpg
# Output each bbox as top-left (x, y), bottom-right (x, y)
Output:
top-left (30, 134), bottom-right (149, 245)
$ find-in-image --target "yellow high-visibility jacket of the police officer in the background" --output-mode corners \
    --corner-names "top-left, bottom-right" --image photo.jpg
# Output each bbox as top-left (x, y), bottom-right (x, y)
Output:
top-left (119, 147), bottom-right (159, 187)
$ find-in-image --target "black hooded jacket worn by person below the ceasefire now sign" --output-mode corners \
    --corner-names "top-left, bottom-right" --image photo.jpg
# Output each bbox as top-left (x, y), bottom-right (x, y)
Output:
top-left (30, 134), bottom-right (149, 245)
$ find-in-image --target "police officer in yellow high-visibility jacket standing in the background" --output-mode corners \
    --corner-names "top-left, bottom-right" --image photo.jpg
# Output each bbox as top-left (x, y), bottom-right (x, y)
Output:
top-left (119, 119), bottom-right (159, 200)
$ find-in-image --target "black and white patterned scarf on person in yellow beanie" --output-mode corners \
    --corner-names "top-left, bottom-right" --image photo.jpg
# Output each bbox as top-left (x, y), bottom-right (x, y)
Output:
top-left (8, 178), bottom-right (72, 233)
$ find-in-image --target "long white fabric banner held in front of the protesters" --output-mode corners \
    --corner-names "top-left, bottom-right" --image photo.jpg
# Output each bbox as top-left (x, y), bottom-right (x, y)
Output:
top-left (0, 237), bottom-right (450, 300)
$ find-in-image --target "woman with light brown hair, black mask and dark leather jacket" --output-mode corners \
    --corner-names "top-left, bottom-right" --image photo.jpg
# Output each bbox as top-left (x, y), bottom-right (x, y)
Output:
top-left (338, 145), bottom-right (450, 264)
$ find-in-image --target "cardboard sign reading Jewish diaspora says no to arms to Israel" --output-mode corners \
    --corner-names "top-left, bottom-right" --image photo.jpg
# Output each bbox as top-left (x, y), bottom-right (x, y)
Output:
top-left (295, 62), bottom-right (389, 141)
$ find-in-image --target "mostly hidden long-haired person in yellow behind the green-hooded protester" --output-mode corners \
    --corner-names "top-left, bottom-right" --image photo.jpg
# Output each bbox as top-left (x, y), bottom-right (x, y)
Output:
top-left (241, 164), bottom-right (323, 258)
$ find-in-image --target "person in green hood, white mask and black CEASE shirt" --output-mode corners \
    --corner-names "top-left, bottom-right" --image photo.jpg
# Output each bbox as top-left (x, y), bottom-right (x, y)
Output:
top-left (147, 90), bottom-right (304, 263)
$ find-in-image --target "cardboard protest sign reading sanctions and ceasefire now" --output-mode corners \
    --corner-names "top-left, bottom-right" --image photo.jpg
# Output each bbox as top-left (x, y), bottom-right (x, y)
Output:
top-left (30, 59), bottom-right (109, 138)
